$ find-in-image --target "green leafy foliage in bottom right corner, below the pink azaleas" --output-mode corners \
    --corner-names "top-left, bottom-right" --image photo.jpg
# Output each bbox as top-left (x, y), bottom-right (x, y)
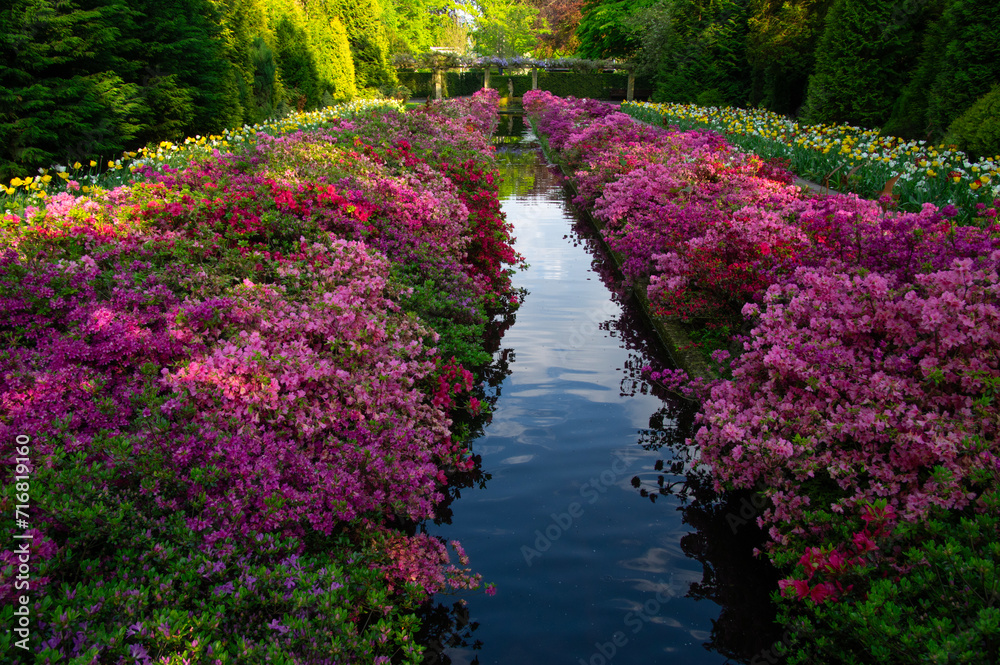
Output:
top-left (783, 514), bottom-right (1000, 665)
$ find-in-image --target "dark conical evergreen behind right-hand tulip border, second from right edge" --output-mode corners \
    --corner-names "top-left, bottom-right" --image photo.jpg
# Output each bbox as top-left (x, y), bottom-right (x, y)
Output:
top-left (803, 0), bottom-right (921, 127)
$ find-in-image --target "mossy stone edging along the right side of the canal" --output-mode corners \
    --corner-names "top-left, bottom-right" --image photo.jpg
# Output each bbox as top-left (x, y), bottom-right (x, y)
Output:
top-left (525, 114), bottom-right (718, 380)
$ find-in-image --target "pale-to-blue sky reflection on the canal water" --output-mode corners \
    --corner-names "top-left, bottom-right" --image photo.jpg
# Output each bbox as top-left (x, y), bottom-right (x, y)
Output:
top-left (430, 131), bottom-right (725, 665)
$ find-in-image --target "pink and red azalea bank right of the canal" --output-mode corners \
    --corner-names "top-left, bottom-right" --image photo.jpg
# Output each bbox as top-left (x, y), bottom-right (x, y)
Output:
top-left (524, 92), bottom-right (1000, 662)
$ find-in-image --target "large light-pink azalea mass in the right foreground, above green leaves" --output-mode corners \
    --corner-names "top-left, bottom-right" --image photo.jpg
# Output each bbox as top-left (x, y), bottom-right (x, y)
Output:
top-left (695, 251), bottom-right (1000, 542)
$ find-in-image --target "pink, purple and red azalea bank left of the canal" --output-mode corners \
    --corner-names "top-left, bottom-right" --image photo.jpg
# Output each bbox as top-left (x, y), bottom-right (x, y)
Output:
top-left (0, 92), bottom-right (519, 663)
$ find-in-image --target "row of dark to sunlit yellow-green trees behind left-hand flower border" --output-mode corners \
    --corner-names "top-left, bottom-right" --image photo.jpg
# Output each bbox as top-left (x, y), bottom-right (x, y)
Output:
top-left (0, 0), bottom-right (395, 180)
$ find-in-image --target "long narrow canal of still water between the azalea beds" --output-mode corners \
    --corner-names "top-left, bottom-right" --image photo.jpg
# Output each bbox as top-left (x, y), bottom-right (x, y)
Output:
top-left (418, 118), bottom-right (773, 665)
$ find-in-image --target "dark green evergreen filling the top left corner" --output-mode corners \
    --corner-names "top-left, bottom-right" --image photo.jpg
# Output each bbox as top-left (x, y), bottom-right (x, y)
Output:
top-left (0, 0), bottom-right (142, 180)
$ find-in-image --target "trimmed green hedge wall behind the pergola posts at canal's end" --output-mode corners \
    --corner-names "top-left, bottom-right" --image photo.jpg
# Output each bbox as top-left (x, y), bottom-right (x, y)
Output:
top-left (399, 70), bottom-right (653, 99)
